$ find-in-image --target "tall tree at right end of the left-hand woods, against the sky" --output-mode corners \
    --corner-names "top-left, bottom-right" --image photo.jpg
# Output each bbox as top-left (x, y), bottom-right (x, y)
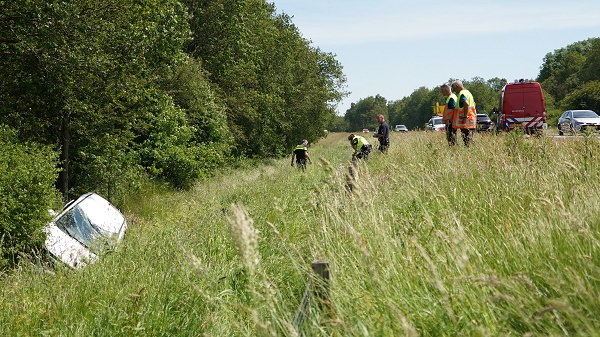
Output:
top-left (186, 0), bottom-right (345, 158)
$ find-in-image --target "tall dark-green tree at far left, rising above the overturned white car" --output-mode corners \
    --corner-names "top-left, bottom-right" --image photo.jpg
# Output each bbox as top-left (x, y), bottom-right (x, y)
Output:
top-left (0, 0), bottom-right (189, 198)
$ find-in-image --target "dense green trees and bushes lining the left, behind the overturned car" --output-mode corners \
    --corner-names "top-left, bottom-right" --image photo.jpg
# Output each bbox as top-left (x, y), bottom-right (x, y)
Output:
top-left (0, 0), bottom-right (345, 267)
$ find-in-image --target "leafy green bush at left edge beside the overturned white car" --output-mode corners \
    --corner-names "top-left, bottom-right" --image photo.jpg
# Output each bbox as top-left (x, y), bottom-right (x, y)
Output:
top-left (0, 126), bottom-right (59, 269)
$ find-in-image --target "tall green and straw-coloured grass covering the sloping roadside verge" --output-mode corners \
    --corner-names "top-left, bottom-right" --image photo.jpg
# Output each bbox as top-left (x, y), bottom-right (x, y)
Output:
top-left (0, 132), bottom-right (600, 336)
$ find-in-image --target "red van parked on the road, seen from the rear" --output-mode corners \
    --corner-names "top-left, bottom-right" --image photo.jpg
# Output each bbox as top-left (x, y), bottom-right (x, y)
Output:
top-left (497, 80), bottom-right (548, 134)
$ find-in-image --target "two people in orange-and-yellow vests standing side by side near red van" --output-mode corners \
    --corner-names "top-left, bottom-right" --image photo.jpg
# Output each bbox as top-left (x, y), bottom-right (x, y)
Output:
top-left (440, 80), bottom-right (477, 147)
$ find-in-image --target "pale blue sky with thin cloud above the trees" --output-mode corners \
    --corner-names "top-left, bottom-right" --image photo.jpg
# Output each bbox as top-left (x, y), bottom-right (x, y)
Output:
top-left (269, 0), bottom-right (600, 115)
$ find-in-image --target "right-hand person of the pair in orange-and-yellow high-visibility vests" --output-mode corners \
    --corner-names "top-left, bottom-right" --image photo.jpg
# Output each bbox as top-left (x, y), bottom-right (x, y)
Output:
top-left (452, 80), bottom-right (477, 146)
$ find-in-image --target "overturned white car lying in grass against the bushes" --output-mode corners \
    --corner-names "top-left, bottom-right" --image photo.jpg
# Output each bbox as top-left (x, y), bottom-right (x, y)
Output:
top-left (44, 193), bottom-right (127, 268)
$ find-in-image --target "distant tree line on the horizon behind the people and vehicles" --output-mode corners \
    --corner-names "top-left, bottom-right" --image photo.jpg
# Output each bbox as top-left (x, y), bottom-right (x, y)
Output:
top-left (338, 38), bottom-right (600, 132)
